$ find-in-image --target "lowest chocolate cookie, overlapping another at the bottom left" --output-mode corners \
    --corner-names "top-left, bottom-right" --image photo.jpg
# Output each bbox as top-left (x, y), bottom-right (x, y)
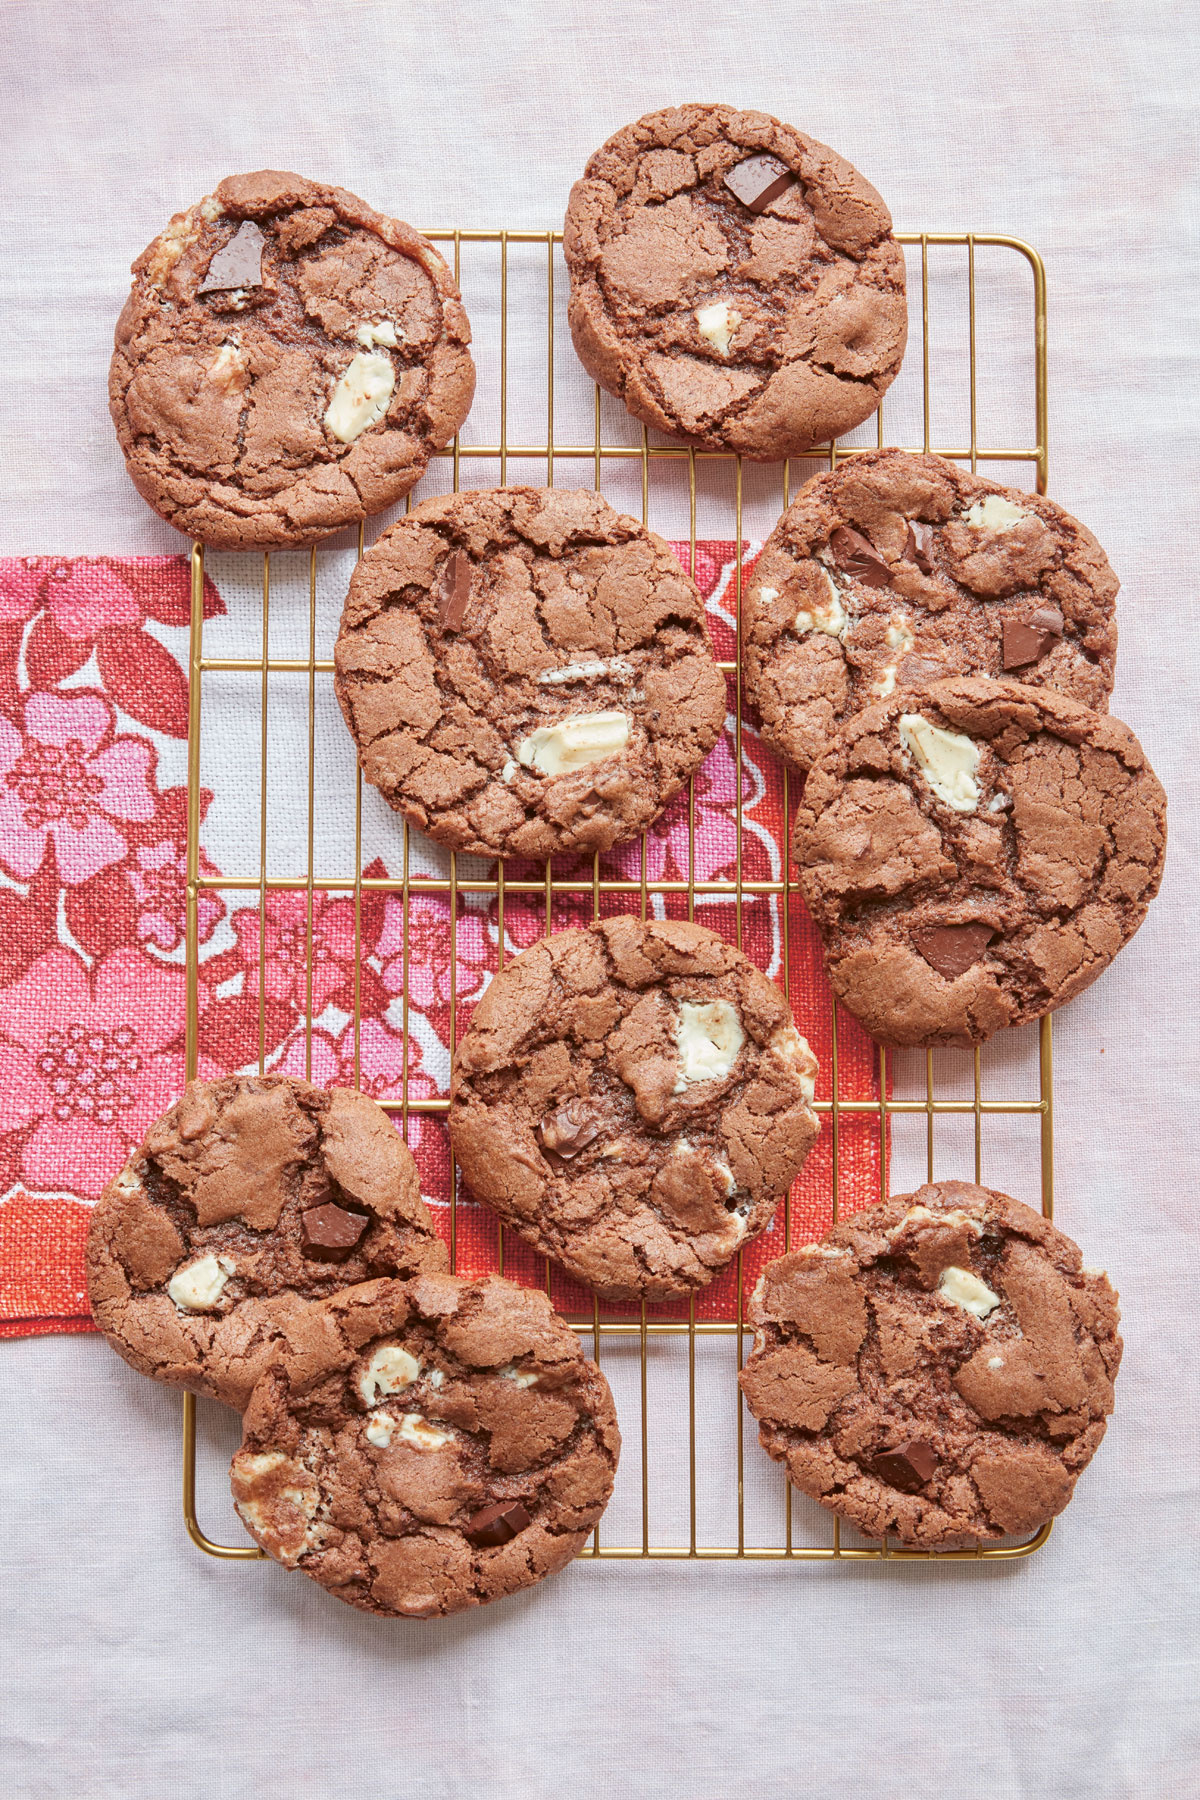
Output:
top-left (230, 1274), bottom-right (621, 1618)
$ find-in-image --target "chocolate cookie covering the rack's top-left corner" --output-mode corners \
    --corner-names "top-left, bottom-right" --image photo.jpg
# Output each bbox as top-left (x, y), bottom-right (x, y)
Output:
top-left (108, 169), bottom-right (475, 551)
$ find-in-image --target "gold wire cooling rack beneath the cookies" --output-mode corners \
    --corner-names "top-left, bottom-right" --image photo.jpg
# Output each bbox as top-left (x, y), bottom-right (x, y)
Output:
top-left (184, 230), bottom-right (1054, 1564)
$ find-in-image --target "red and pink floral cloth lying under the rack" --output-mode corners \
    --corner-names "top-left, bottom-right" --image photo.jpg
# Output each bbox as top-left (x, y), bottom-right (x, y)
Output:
top-left (0, 544), bottom-right (880, 1336)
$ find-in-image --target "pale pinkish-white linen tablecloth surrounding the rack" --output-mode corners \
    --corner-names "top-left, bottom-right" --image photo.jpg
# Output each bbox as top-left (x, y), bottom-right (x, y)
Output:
top-left (0, 0), bottom-right (1200, 1800)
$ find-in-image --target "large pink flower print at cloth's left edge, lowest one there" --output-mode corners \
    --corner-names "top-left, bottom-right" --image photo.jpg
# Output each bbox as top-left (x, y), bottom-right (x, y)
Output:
top-left (0, 949), bottom-right (195, 1197)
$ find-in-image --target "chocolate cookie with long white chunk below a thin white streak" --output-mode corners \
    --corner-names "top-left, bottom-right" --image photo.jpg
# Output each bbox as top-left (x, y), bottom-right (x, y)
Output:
top-left (335, 488), bottom-right (725, 857)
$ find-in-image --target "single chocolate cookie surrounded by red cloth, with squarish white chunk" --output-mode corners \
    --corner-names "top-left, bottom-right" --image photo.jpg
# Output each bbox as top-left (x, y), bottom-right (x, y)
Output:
top-left (450, 916), bottom-right (820, 1301)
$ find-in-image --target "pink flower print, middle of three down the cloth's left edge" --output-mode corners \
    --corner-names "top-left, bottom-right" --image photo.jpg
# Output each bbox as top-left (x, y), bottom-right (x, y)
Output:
top-left (0, 693), bottom-right (157, 887)
